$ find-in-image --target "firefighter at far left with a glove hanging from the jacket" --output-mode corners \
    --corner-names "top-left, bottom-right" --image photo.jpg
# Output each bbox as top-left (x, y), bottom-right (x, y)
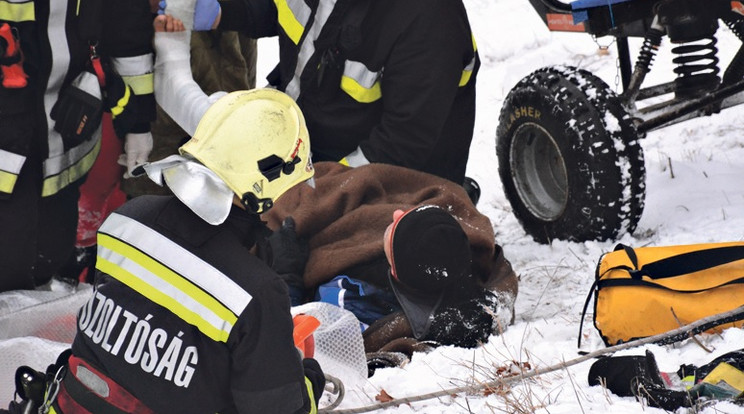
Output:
top-left (0, 0), bottom-right (155, 291)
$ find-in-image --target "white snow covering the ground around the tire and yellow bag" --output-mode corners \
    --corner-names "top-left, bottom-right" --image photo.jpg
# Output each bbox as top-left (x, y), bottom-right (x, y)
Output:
top-left (0, 0), bottom-right (744, 414)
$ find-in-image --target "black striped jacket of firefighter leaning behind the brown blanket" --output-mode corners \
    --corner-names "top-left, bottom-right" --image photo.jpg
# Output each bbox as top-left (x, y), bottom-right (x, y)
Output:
top-left (220, 0), bottom-right (480, 184)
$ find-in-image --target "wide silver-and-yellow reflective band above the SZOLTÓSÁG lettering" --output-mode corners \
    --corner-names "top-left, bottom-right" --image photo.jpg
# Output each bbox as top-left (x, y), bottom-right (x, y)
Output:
top-left (96, 213), bottom-right (252, 342)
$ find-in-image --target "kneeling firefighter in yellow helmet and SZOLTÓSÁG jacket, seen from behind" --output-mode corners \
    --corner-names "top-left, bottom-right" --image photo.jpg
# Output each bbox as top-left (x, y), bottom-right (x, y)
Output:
top-left (3, 89), bottom-right (325, 413)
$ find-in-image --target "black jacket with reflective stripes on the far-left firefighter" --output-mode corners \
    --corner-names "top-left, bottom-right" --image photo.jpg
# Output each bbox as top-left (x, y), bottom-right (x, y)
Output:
top-left (0, 0), bottom-right (154, 197)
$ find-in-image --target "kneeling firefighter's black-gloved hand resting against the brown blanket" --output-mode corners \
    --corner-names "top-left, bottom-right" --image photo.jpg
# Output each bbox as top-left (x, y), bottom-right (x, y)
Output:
top-left (268, 216), bottom-right (310, 278)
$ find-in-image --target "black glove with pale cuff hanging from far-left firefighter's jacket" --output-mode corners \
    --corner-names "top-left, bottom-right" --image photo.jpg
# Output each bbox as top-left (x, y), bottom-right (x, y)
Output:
top-left (50, 71), bottom-right (103, 150)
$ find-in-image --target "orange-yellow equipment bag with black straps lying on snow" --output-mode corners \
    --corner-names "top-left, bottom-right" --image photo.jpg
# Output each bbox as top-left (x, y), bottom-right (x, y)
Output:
top-left (579, 242), bottom-right (744, 346)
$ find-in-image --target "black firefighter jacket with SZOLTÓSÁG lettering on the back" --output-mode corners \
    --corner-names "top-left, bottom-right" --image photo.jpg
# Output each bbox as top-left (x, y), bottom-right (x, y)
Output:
top-left (72, 196), bottom-right (314, 414)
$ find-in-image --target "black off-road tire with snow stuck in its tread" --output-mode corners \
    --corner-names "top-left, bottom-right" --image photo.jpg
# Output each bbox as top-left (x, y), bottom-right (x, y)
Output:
top-left (496, 66), bottom-right (646, 243)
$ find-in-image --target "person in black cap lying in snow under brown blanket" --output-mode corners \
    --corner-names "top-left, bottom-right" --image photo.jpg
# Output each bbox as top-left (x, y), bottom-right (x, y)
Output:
top-left (262, 162), bottom-right (518, 353)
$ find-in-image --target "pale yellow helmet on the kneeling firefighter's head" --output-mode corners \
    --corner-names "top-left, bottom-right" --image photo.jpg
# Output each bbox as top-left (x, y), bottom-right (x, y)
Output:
top-left (179, 88), bottom-right (314, 213)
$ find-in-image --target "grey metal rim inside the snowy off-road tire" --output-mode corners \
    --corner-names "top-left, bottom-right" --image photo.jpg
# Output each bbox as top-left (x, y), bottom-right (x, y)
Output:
top-left (509, 123), bottom-right (568, 221)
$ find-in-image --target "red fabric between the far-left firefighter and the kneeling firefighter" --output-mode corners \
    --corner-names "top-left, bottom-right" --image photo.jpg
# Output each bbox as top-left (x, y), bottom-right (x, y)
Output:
top-left (75, 113), bottom-right (127, 247)
